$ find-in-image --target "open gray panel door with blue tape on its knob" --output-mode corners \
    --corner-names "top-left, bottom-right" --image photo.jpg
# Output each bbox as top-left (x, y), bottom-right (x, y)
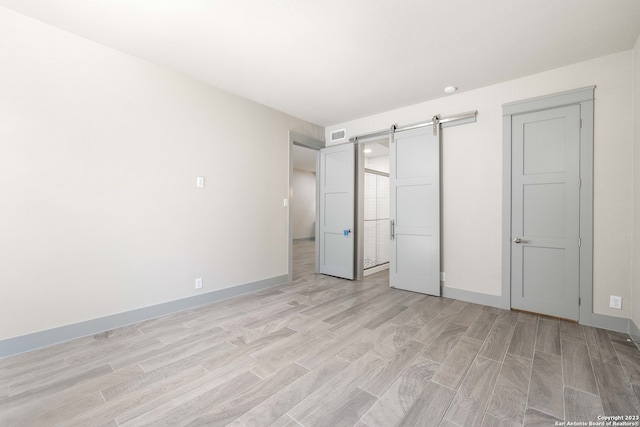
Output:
top-left (318, 144), bottom-right (355, 280)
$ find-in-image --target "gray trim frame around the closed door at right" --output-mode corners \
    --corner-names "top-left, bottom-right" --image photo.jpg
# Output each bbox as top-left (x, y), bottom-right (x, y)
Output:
top-left (502, 86), bottom-right (596, 325)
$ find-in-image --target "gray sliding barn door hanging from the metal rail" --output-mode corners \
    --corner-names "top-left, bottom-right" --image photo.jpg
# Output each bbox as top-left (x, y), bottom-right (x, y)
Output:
top-left (389, 127), bottom-right (440, 295)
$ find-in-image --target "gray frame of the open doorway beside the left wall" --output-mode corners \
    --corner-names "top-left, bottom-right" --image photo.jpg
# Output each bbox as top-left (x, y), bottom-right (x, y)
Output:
top-left (287, 131), bottom-right (325, 282)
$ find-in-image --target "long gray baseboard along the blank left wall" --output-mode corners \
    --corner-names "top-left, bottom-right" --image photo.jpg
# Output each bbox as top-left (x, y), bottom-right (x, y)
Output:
top-left (0, 274), bottom-right (288, 357)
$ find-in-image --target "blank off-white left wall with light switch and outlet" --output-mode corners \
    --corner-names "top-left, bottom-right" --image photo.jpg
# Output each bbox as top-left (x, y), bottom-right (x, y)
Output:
top-left (0, 8), bottom-right (323, 340)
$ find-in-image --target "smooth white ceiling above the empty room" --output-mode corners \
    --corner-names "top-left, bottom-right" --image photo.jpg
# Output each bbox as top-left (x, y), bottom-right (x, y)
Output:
top-left (0, 0), bottom-right (640, 126)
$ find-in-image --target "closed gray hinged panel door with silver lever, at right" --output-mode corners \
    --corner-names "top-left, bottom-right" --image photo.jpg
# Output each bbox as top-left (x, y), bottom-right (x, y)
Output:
top-left (511, 105), bottom-right (580, 320)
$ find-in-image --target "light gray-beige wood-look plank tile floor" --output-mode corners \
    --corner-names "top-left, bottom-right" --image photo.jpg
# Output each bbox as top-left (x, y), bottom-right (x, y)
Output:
top-left (0, 242), bottom-right (640, 427)
